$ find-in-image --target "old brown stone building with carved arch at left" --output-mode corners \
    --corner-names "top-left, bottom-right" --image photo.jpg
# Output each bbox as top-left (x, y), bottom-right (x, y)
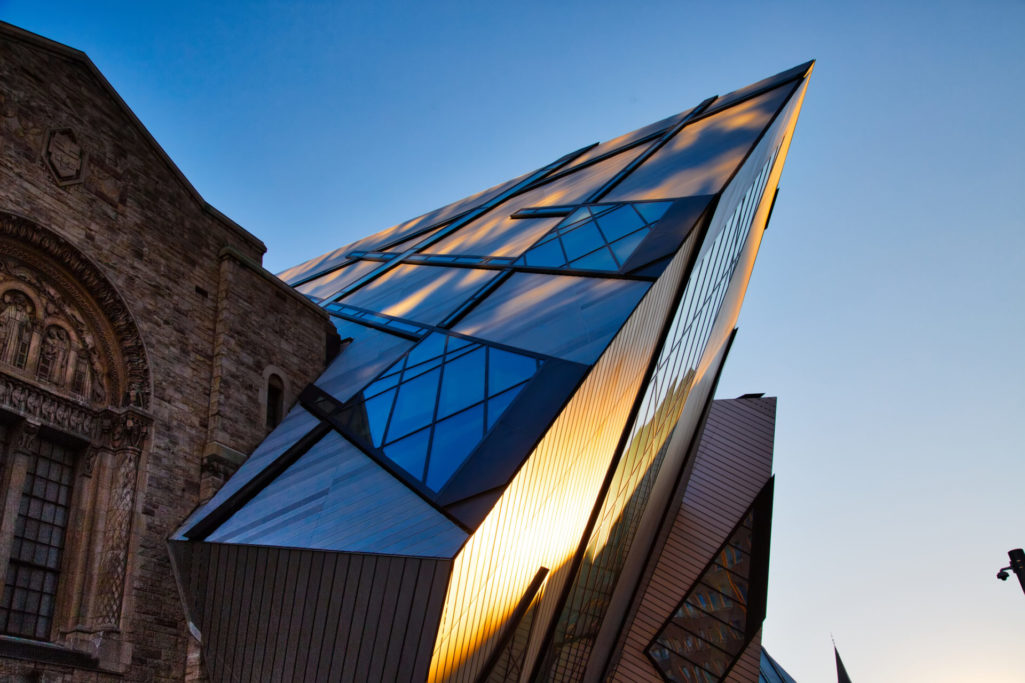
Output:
top-left (0, 24), bottom-right (337, 681)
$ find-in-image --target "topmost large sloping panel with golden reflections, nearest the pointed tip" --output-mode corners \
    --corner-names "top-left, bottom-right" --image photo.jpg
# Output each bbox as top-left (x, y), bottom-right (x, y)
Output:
top-left (605, 83), bottom-right (795, 201)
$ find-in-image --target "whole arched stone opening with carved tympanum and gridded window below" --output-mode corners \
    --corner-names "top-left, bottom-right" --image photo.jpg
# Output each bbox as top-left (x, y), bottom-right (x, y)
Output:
top-left (0, 211), bottom-right (152, 661)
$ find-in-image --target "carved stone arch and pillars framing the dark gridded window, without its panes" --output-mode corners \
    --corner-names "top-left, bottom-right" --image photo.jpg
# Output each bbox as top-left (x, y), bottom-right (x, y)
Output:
top-left (0, 211), bottom-right (152, 661)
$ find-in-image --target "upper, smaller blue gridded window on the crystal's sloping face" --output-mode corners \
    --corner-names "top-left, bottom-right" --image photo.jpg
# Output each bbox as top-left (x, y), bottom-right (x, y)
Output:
top-left (516, 202), bottom-right (671, 271)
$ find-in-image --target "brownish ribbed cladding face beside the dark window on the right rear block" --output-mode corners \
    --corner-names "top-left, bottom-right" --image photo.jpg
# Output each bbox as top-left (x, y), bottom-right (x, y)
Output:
top-left (614, 398), bottom-right (776, 681)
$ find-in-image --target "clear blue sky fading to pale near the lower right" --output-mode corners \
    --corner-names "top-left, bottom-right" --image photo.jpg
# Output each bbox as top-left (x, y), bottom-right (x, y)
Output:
top-left (0, 0), bottom-right (1025, 683)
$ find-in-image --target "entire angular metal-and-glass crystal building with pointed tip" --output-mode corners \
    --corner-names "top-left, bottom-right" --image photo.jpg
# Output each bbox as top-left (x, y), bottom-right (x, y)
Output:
top-left (169, 63), bottom-right (812, 682)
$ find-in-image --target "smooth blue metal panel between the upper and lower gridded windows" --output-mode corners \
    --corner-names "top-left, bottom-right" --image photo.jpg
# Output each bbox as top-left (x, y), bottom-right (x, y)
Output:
top-left (453, 273), bottom-right (651, 365)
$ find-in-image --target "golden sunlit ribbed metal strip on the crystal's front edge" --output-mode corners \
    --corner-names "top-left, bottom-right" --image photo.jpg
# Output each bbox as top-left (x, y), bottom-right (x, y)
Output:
top-left (431, 224), bottom-right (691, 683)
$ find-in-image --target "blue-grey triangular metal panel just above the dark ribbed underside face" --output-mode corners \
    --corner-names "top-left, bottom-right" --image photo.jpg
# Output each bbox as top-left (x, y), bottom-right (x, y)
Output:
top-left (207, 432), bottom-right (466, 557)
